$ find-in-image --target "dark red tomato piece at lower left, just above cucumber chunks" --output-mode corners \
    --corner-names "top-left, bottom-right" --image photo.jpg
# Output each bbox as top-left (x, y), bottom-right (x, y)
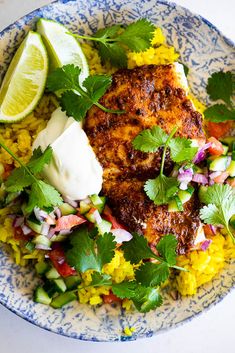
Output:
top-left (48, 246), bottom-right (77, 277)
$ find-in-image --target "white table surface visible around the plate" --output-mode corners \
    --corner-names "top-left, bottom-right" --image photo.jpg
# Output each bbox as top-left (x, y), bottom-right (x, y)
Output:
top-left (0, 0), bottom-right (235, 353)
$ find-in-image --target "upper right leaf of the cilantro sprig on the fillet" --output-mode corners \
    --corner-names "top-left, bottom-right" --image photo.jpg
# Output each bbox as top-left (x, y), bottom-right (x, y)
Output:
top-left (169, 137), bottom-right (198, 163)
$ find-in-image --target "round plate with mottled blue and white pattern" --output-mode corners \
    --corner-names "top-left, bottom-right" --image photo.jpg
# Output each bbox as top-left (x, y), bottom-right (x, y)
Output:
top-left (0, 0), bottom-right (235, 341)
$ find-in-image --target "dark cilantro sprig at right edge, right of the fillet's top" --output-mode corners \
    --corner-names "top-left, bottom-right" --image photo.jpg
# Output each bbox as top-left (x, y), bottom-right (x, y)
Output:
top-left (204, 71), bottom-right (235, 123)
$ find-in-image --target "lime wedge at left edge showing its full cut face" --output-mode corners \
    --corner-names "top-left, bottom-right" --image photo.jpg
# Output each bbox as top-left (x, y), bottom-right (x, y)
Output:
top-left (0, 32), bottom-right (48, 123)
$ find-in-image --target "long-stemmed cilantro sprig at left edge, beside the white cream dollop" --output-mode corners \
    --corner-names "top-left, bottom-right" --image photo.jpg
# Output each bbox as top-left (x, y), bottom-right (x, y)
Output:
top-left (0, 141), bottom-right (62, 213)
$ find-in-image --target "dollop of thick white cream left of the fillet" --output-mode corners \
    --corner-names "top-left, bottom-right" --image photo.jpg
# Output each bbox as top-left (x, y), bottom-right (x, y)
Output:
top-left (33, 108), bottom-right (103, 200)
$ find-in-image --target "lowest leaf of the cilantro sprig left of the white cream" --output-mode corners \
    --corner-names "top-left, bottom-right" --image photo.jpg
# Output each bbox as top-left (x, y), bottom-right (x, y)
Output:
top-left (26, 180), bottom-right (63, 212)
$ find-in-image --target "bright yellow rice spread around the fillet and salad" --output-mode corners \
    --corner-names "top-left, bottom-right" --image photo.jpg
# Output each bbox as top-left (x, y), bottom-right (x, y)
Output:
top-left (0, 28), bottom-right (235, 306)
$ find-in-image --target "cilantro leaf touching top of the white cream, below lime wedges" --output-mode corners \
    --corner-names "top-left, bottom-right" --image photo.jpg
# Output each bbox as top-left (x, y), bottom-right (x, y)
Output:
top-left (60, 91), bottom-right (93, 121)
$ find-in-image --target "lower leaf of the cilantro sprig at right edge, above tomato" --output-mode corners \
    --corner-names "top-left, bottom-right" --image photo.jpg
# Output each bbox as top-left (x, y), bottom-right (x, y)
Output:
top-left (204, 104), bottom-right (235, 123)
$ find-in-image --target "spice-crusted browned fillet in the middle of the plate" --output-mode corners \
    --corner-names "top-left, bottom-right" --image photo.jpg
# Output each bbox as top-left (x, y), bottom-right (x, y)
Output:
top-left (84, 64), bottom-right (205, 254)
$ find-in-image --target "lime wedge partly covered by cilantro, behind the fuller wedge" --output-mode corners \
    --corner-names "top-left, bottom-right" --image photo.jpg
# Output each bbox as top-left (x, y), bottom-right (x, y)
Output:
top-left (37, 18), bottom-right (89, 84)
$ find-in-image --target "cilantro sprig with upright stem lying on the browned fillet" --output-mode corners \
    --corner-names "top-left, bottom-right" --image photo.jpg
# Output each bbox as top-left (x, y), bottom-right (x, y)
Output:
top-left (133, 126), bottom-right (198, 205)
